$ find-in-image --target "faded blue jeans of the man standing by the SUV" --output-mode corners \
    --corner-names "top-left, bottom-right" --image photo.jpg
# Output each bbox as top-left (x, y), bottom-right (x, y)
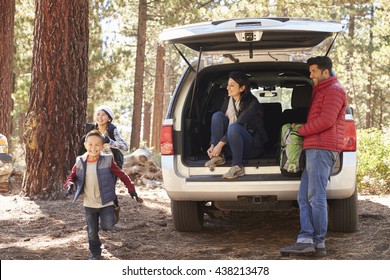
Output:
top-left (297, 149), bottom-right (338, 247)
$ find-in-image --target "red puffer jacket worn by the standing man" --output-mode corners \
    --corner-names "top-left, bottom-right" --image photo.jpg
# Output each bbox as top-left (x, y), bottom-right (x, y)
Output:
top-left (298, 77), bottom-right (347, 152)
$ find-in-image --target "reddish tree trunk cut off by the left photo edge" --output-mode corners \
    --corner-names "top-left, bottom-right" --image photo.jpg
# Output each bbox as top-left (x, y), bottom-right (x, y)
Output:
top-left (0, 0), bottom-right (15, 138)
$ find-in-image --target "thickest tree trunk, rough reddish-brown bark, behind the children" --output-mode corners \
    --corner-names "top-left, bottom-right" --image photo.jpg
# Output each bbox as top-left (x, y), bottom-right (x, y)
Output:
top-left (23, 0), bottom-right (88, 199)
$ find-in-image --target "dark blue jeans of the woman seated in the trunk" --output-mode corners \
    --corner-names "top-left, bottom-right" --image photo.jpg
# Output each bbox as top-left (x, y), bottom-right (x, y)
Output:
top-left (211, 112), bottom-right (259, 167)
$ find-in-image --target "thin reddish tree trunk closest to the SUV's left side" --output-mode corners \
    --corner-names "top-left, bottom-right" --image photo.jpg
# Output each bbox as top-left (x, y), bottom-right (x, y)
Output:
top-left (151, 45), bottom-right (165, 152)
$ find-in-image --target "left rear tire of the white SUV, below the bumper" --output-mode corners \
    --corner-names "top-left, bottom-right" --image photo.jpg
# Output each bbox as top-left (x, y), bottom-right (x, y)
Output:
top-left (171, 200), bottom-right (204, 232)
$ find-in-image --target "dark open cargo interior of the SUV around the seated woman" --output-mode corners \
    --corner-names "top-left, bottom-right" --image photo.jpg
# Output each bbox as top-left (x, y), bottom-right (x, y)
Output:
top-left (179, 62), bottom-right (312, 166)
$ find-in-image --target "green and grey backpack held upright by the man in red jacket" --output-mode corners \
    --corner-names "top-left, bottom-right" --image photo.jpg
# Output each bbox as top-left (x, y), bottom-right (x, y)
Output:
top-left (280, 123), bottom-right (305, 177)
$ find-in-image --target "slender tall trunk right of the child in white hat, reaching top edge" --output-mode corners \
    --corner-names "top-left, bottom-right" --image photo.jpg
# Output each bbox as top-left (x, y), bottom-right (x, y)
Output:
top-left (130, 0), bottom-right (147, 149)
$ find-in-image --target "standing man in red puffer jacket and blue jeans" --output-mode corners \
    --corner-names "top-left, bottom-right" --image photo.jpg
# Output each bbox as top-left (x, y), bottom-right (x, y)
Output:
top-left (280, 56), bottom-right (347, 256)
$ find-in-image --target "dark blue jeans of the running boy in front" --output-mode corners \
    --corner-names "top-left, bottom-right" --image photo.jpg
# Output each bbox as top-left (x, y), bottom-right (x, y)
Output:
top-left (84, 205), bottom-right (115, 256)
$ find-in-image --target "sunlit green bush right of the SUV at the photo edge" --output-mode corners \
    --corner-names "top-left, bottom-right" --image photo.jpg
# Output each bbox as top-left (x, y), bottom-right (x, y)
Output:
top-left (356, 127), bottom-right (390, 194)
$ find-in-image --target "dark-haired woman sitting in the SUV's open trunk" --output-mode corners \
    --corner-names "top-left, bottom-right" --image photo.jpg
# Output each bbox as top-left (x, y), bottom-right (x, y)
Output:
top-left (205, 72), bottom-right (267, 179)
